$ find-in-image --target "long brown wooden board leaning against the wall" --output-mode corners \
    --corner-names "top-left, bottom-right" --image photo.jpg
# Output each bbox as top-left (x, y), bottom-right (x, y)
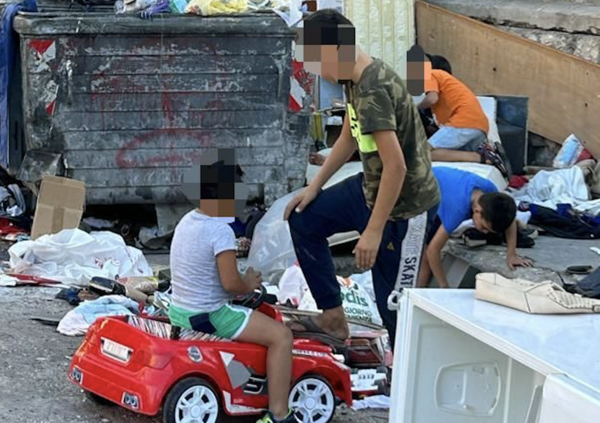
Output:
top-left (416, 1), bottom-right (600, 159)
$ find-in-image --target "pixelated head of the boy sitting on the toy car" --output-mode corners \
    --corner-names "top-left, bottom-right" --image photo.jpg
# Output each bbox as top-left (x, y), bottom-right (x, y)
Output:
top-left (181, 148), bottom-right (248, 219)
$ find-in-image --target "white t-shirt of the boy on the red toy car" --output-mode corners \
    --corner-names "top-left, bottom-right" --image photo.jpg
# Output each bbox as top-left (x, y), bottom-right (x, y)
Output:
top-left (171, 210), bottom-right (236, 313)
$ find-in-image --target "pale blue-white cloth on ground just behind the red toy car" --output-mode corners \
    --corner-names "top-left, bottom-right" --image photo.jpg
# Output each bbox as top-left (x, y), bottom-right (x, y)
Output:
top-left (56, 295), bottom-right (139, 336)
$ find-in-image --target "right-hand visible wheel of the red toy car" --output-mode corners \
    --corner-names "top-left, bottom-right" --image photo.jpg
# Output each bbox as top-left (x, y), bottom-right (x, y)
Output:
top-left (289, 376), bottom-right (335, 423)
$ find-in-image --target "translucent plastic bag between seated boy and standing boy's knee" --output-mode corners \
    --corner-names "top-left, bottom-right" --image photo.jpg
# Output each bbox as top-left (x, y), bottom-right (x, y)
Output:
top-left (247, 188), bottom-right (304, 285)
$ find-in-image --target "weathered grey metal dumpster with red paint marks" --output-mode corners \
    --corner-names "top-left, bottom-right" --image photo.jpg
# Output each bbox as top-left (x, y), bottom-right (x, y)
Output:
top-left (14, 12), bottom-right (309, 205)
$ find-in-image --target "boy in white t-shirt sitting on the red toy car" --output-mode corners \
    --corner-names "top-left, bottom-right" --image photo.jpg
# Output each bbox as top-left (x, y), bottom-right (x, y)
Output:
top-left (169, 150), bottom-right (295, 423)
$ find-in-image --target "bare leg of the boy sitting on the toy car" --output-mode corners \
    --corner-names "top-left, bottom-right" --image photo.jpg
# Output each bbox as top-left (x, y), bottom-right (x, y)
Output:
top-left (237, 311), bottom-right (293, 420)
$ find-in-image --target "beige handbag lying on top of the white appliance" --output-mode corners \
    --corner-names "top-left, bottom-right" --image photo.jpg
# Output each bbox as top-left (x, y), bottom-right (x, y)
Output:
top-left (475, 273), bottom-right (600, 314)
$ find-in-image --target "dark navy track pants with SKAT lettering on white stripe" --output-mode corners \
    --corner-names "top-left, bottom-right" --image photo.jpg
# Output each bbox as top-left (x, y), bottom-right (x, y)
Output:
top-left (289, 173), bottom-right (437, 348)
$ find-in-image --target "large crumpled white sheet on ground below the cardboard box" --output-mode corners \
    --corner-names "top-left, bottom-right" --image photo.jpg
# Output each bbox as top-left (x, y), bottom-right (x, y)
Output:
top-left (8, 229), bottom-right (152, 286)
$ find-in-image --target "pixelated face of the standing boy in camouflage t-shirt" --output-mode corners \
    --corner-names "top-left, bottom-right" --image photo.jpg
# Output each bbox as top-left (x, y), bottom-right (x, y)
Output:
top-left (295, 22), bottom-right (357, 83)
